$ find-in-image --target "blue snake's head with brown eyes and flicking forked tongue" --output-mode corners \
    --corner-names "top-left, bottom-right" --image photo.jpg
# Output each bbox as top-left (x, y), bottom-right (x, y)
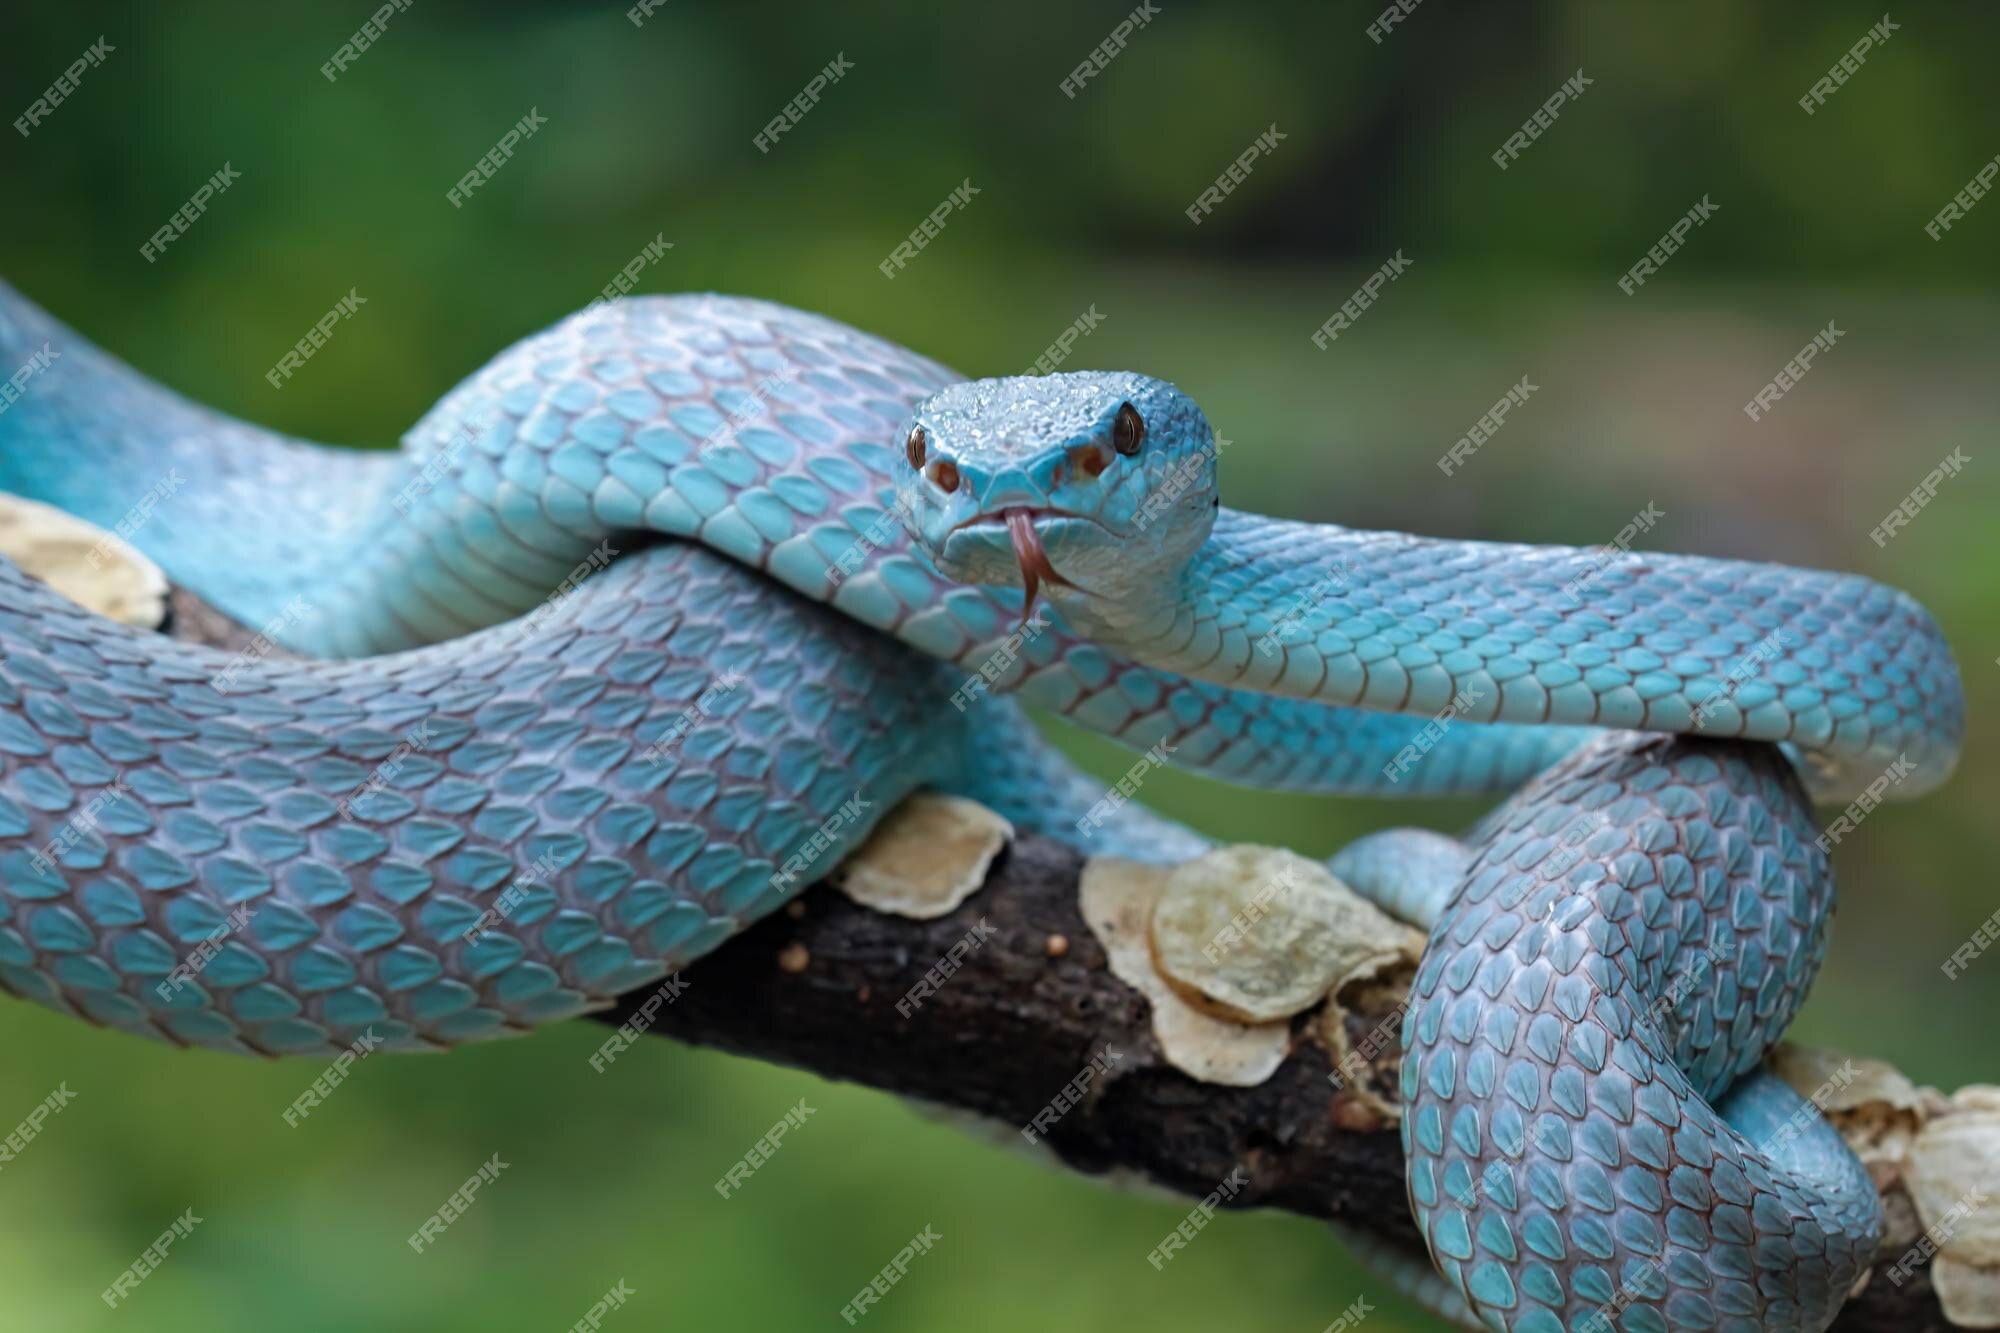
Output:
top-left (896, 370), bottom-right (1218, 606)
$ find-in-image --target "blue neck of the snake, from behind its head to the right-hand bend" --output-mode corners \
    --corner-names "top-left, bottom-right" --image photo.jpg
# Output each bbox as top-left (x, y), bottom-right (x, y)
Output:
top-left (1058, 506), bottom-right (1964, 801)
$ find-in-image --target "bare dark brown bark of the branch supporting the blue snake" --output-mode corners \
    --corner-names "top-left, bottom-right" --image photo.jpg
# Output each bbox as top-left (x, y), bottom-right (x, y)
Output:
top-left (172, 592), bottom-right (1952, 1333)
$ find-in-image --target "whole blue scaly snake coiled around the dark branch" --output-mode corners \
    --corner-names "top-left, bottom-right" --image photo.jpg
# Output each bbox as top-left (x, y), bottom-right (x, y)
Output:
top-left (0, 284), bottom-right (1962, 1333)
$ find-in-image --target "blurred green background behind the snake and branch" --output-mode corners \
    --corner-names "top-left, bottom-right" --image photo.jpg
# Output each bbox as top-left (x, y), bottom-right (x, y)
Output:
top-left (0, 0), bottom-right (2000, 1333)
